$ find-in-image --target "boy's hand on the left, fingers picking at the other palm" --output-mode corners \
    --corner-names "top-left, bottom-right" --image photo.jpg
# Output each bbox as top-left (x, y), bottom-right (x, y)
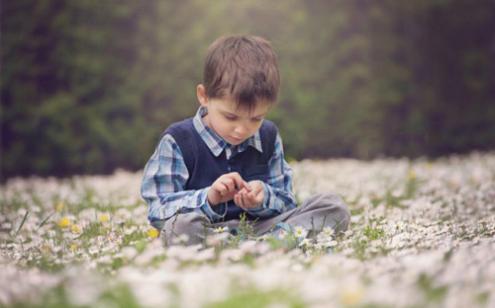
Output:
top-left (208, 172), bottom-right (251, 206)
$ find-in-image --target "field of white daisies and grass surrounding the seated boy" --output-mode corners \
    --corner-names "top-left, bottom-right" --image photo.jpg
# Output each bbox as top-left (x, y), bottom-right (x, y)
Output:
top-left (0, 153), bottom-right (495, 307)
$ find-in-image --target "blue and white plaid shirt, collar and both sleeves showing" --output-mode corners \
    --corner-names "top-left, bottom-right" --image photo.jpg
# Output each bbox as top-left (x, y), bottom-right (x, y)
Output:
top-left (141, 107), bottom-right (296, 228)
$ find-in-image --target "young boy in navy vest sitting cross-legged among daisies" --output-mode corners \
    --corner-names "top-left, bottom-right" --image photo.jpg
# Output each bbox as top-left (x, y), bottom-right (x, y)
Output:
top-left (141, 36), bottom-right (350, 245)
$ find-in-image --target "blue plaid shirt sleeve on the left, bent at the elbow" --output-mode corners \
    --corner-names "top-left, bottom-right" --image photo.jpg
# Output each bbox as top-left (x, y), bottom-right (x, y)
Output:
top-left (141, 134), bottom-right (225, 229)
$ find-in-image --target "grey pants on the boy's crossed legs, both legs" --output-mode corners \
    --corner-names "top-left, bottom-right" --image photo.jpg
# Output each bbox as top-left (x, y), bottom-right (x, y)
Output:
top-left (161, 194), bottom-right (350, 245)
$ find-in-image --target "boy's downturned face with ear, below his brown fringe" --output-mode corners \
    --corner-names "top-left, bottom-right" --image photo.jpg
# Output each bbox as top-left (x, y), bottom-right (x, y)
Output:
top-left (197, 85), bottom-right (271, 145)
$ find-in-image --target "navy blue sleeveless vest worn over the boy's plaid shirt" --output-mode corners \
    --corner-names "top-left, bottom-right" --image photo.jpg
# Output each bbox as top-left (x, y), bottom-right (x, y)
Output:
top-left (164, 118), bottom-right (277, 221)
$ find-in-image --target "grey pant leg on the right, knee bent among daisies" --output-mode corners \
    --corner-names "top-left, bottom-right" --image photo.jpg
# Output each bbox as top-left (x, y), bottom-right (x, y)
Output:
top-left (254, 193), bottom-right (351, 235)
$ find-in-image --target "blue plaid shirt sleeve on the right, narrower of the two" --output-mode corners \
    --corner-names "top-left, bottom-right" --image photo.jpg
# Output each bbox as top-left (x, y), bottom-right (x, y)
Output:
top-left (248, 134), bottom-right (297, 218)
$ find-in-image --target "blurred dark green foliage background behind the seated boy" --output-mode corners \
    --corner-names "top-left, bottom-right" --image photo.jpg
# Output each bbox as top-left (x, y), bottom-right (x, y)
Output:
top-left (1, 0), bottom-right (495, 180)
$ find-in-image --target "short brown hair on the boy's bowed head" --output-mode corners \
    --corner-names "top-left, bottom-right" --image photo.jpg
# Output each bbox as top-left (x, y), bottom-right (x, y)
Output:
top-left (203, 35), bottom-right (280, 109)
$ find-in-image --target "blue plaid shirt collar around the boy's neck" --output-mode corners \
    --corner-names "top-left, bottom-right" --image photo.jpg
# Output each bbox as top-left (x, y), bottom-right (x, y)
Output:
top-left (193, 106), bottom-right (263, 157)
